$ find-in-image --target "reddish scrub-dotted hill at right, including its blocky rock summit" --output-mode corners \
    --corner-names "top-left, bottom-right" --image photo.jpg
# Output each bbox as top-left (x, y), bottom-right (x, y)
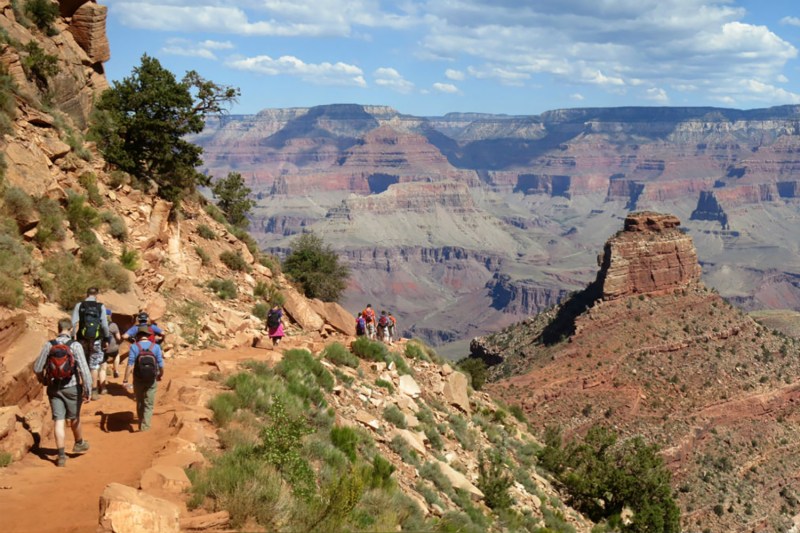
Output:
top-left (472, 213), bottom-right (800, 532)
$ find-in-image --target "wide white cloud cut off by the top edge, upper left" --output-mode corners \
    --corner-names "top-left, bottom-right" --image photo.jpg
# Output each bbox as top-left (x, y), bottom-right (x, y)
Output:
top-left (110, 0), bottom-right (419, 37)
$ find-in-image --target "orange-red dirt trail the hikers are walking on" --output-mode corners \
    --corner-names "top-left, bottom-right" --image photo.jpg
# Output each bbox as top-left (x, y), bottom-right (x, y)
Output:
top-left (0, 349), bottom-right (272, 533)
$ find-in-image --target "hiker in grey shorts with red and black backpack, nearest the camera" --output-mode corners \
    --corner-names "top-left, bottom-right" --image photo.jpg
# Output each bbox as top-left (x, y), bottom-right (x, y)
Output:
top-left (33, 318), bottom-right (92, 466)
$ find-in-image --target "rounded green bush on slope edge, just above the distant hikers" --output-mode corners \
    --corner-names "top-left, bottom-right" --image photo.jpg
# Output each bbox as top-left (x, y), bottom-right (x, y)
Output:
top-left (283, 233), bottom-right (350, 302)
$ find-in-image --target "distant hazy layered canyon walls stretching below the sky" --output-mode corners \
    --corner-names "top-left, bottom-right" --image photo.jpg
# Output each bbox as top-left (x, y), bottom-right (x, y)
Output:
top-left (196, 105), bottom-right (800, 350)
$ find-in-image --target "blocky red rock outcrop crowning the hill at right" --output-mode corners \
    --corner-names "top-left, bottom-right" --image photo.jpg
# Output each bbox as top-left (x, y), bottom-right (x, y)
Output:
top-left (597, 212), bottom-right (700, 300)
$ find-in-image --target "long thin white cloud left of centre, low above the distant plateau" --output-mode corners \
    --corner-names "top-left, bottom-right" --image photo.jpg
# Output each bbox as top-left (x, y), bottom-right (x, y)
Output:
top-left (228, 55), bottom-right (367, 87)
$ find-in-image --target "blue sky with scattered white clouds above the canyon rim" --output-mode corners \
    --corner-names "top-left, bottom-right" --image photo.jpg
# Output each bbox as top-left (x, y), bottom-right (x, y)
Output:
top-left (100, 0), bottom-right (800, 116)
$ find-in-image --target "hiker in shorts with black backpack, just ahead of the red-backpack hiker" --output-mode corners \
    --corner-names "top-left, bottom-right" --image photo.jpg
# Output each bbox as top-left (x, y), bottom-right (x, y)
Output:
top-left (72, 287), bottom-right (109, 400)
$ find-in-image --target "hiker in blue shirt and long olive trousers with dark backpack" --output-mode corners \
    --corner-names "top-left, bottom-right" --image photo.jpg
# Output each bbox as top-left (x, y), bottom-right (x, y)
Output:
top-left (122, 324), bottom-right (164, 431)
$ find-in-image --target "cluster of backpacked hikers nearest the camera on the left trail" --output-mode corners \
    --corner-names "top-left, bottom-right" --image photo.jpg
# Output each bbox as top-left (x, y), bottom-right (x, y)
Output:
top-left (33, 287), bottom-right (164, 466)
